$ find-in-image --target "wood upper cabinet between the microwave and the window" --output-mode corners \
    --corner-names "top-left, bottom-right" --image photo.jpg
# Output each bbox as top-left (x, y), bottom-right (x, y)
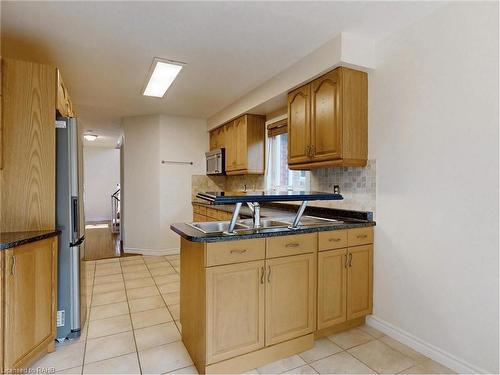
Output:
top-left (224, 115), bottom-right (265, 175)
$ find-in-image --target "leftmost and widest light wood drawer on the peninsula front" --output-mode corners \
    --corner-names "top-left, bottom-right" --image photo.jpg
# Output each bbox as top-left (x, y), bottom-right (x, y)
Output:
top-left (206, 238), bottom-right (266, 267)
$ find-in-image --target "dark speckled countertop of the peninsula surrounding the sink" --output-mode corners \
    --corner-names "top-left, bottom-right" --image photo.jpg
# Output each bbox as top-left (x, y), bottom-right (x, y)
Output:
top-left (174, 202), bottom-right (376, 242)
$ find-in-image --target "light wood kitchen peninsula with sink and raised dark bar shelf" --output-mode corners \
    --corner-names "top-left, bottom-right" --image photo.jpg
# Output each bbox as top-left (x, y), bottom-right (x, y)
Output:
top-left (171, 192), bottom-right (375, 373)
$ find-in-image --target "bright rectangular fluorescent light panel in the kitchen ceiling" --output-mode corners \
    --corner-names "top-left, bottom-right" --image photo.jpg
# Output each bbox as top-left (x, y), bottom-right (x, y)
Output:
top-left (142, 59), bottom-right (184, 98)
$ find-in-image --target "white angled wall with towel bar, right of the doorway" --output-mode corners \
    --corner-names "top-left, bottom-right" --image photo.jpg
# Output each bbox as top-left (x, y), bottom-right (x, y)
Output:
top-left (123, 115), bottom-right (208, 254)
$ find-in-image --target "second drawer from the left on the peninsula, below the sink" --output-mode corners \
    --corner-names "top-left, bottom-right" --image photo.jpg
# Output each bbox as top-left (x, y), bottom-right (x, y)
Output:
top-left (266, 233), bottom-right (317, 258)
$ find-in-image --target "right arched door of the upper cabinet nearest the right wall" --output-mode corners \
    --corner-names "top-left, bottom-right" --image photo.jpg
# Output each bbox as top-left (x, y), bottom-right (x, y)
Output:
top-left (311, 69), bottom-right (342, 161)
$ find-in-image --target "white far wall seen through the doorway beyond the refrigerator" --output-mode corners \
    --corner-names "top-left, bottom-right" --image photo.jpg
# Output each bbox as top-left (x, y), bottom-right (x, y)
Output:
top-left (83, 147), bottom-right (120, 222)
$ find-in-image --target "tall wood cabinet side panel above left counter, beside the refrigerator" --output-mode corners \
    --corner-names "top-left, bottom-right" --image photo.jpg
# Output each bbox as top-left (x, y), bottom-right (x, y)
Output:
top-left (0, 58), bottom-right (56, 232)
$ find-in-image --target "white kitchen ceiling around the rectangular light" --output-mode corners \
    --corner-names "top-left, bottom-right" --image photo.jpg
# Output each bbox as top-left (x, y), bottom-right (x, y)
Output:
top-left (1, 1), bottom-right (443, 134)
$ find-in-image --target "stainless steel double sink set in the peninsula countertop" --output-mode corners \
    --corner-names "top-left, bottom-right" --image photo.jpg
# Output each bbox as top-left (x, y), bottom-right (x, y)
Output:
top-left (188, 216), bottom-right (342, 234)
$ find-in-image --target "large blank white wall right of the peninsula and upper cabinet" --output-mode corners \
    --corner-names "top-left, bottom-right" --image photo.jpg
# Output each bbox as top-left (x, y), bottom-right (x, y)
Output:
top-left (369, 2), bottom-right (499, 373)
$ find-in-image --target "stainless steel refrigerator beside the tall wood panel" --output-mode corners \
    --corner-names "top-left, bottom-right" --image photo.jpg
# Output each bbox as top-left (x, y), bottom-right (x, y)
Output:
top-left (56, 118), bottom-right (87, 341)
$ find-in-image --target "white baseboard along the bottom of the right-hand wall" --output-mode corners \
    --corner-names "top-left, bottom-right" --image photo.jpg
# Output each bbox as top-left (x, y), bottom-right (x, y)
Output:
top-left (366, 315), bottom-right (490, 374)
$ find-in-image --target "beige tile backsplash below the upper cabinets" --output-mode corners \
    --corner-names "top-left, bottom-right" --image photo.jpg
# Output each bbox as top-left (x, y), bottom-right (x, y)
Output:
top-left (191, 160), bottom-right (377, 217)
